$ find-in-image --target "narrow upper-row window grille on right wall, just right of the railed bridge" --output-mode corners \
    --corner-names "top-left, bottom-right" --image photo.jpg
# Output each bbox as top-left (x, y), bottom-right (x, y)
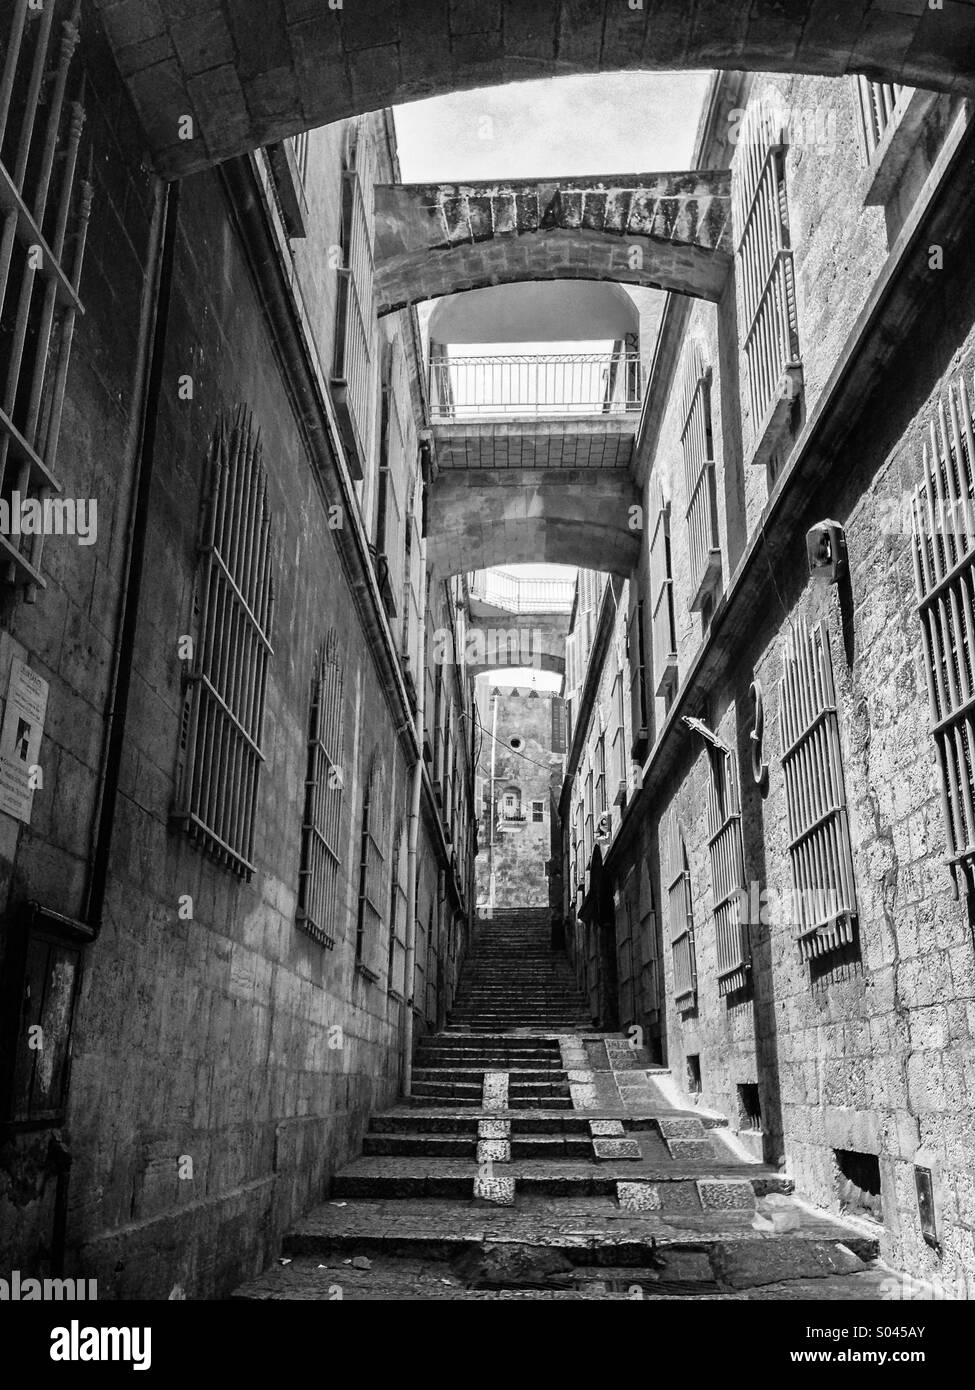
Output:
top-left (680, 339), bottom-right (720, 612)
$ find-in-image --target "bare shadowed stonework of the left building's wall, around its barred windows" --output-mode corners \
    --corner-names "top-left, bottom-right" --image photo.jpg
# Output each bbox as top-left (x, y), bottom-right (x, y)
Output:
top-left (0, 27), bottom-right (472, 1298)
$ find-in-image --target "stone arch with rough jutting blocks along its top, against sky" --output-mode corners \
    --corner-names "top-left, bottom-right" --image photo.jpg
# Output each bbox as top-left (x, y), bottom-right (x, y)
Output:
top-left (374, 170), bottom-right (732, 316)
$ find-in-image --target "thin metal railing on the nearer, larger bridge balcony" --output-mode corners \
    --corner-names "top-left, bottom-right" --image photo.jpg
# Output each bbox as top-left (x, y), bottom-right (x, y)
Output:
top-left (430, 352), bottom-right (641, 423)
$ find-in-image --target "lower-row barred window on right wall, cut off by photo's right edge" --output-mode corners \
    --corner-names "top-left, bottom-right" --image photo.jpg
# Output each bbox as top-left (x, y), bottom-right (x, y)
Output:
top-left (912, 375), bottom-right (975, 897)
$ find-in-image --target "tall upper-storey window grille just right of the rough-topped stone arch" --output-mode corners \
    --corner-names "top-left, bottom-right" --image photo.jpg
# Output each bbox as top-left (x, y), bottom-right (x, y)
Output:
top-left (732, 95), bottom-right (801, 450)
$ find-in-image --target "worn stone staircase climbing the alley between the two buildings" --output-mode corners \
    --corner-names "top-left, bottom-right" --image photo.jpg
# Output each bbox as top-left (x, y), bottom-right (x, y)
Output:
top-left (234, 912), bottom-right (887, 1301)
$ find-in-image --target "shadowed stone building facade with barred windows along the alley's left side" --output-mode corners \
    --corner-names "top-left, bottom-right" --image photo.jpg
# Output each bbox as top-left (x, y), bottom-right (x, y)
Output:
top-left (0, 4), bottom-right (474, 1298)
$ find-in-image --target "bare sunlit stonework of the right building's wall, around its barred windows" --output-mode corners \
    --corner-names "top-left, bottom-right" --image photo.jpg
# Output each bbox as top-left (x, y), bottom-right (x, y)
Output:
top-left (627, 79), bottom-right (975, 1279)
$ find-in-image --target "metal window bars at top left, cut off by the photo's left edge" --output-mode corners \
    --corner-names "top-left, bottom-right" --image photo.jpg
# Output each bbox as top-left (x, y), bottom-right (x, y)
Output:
top-left (0, 0), bottom-right (92, 602)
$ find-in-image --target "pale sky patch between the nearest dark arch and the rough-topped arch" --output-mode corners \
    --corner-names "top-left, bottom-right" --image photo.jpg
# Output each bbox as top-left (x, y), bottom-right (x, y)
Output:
top-left (394, 72), bottom-right (711, 183)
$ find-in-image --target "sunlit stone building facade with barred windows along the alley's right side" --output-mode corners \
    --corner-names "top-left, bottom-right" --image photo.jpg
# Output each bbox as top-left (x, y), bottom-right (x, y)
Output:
top-left (562, 74), bottom-right (975, 1283)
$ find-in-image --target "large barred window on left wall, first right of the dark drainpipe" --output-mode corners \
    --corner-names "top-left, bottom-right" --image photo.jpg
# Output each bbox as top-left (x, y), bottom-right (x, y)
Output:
top-left (175, 407), bottom-right (274, 880)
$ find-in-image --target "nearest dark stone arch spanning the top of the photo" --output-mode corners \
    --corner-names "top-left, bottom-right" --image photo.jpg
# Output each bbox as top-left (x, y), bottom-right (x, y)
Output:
top-left (95, 0), bottom-right (975, 178)
